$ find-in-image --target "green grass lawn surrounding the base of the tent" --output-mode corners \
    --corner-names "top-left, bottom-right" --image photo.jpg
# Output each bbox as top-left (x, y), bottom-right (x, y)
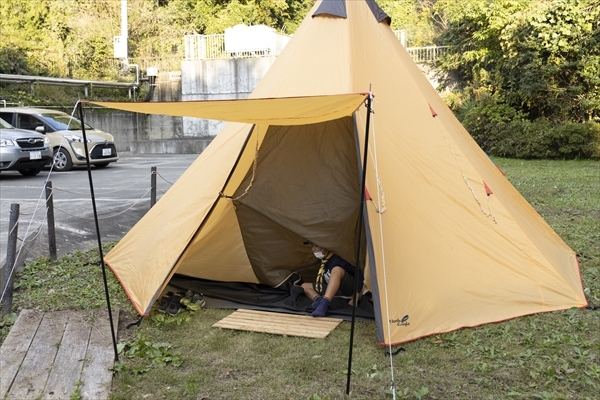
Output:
top-left (0, 159), bottom-right (600, 400)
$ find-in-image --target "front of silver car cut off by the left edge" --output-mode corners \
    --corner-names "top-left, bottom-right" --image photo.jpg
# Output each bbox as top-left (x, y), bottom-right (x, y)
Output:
top-left (0, 119), bottom-right (52, 176)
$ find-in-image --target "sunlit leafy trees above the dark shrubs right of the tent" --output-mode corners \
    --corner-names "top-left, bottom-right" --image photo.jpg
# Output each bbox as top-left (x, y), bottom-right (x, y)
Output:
top-left (436, 0), bottom-right (600, 122)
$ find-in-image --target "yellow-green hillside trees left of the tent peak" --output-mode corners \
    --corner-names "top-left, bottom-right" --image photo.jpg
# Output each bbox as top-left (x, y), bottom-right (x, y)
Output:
top-left (0, 0), bottom-right (314, 80)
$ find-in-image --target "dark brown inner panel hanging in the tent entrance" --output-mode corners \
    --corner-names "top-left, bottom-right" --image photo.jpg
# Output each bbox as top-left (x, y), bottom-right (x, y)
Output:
top-left (232, 117), bottom-right (360, 286)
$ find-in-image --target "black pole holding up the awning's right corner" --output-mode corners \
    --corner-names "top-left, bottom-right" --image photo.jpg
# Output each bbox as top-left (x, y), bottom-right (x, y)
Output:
top-left (346, 88), bottom-right (373, 395)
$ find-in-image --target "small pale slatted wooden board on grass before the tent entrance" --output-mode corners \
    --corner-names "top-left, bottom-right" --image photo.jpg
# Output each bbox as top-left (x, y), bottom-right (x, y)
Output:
top-left (213, 309), bottom-right (342, 339)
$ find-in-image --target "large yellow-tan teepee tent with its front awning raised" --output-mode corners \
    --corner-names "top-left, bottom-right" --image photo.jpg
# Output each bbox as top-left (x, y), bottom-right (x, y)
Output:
top-left (98, 0), bottom-right (587, 344)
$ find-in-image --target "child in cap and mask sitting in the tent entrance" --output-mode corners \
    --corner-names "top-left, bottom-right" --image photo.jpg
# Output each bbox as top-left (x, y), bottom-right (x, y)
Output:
top-left (302, 243), bottom-right (364, 317)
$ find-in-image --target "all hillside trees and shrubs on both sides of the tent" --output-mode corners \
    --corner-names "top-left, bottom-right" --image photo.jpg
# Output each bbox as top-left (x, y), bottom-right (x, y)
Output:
top-left (0, 0), bottom-right (600, 159)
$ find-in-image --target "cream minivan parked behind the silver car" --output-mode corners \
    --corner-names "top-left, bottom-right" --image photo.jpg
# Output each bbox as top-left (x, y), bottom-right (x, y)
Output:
top-left (0, 107), bottom-right (119, 171)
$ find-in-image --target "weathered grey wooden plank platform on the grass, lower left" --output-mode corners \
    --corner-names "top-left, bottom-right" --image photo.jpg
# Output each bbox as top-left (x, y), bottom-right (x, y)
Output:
top-left (0, 310), bottom-right (119, 400)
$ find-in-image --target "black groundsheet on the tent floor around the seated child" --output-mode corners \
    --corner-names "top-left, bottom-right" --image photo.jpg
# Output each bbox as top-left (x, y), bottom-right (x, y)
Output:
top-left (169, 274), bottom-right (374, 321)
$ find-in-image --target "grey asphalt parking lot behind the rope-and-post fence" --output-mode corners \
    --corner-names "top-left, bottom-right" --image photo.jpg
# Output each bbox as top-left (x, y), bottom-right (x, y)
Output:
top-left (0, 153), bottom-right (198, 265)
